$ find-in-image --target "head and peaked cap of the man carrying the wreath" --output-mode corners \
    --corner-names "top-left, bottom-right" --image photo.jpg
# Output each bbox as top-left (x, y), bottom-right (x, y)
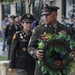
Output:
top-left (42, 4), bottom-right (59, 24)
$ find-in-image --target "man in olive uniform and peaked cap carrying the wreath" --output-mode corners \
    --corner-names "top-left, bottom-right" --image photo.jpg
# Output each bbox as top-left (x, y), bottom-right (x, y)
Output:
top-left (28, 4), bottom-right (72, 75)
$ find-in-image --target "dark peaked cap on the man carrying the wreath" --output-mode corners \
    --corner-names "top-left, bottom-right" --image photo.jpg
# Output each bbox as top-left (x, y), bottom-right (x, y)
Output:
top-left (42, 4), bottom-right (59, 14)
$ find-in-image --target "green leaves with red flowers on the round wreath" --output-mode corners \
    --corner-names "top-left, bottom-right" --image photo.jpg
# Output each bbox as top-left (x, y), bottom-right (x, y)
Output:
top-left (37, 32), bottom-right (75, 75)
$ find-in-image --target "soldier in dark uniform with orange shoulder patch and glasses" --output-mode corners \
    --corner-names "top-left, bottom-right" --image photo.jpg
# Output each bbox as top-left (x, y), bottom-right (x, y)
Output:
top-left (9, 14), bottom-right (35, 75)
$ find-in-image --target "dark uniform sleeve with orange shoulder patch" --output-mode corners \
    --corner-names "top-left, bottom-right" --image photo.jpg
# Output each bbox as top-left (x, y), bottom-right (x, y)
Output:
top-left (9, 34), bottom-right (18, 69)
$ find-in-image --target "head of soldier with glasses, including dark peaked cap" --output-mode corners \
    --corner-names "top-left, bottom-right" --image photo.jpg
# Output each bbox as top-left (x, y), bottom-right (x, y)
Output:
top-left (20, 13), bottom-right (35, 30)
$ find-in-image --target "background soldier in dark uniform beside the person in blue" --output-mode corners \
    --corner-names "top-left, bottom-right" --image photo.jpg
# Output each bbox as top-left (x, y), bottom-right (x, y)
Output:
top-left (5, 15), bottom-right (20, 59)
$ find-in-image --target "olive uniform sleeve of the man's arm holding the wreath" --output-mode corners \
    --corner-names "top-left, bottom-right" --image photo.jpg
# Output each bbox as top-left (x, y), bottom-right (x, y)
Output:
top-left (28, 28), bottom-right (38, 59)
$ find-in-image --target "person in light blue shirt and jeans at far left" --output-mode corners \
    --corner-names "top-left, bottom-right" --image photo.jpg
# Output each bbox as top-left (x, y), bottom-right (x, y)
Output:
top-left (2, 15), bottom-right (10, 51)
